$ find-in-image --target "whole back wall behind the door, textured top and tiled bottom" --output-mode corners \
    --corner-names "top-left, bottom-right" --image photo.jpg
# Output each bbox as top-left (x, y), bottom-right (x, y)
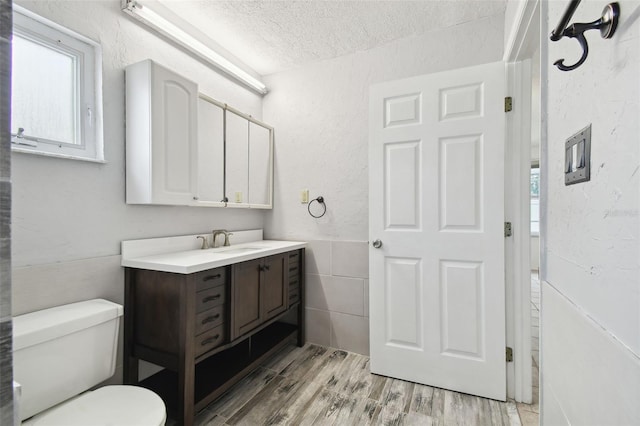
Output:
top-left (263, 15), bottom-right (504, 354)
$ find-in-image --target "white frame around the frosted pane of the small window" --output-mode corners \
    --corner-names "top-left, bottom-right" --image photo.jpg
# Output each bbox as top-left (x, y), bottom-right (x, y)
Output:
top-left (11, 5), bottom-right (105, 163)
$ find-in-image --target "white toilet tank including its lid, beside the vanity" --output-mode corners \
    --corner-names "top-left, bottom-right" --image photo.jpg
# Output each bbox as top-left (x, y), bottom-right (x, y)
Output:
top-left (13, 299), bottom-right (123, 420)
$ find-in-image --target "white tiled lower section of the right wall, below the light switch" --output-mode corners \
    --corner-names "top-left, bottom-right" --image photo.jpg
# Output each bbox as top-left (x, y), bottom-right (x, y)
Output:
top-left (540, 282), bottom-right (640, 425)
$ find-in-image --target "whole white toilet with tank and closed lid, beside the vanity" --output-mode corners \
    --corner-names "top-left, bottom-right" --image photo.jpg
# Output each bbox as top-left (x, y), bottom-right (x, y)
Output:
top-left (13, 299), bottom-right (166, 426)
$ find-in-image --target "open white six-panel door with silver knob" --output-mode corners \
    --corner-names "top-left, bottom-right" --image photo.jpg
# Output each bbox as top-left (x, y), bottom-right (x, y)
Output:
top-left (369, 62), bottom-right (506, 400)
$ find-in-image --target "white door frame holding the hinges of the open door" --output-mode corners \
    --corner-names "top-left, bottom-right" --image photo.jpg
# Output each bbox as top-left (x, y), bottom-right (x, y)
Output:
top-left (503, 0), bottom-right (542, 403)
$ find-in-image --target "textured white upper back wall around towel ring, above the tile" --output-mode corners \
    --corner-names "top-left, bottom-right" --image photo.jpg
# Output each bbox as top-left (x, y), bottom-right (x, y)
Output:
top-left (263, 15), bottom-right (504, 241)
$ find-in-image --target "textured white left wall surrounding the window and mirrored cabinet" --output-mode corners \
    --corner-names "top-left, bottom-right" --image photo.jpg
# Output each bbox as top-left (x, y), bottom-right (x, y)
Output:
top-left (12, 0), bottom-right (263, 266)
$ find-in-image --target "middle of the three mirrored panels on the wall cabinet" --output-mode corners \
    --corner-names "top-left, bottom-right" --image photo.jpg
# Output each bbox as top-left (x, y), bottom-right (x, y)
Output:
top-left (225, 109), bottom-right (249, 207)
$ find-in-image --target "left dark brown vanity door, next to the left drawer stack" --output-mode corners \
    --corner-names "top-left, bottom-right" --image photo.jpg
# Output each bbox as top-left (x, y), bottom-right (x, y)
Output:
top-left (231, 259), bottom-right (263, 340)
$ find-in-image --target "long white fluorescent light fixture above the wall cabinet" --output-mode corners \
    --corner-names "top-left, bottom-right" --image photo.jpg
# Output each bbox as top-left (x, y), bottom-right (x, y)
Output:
top-left (122, 0), bottom-right (268, 95)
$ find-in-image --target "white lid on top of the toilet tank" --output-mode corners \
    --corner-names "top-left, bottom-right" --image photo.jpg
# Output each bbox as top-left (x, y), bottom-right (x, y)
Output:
top-left (13, 299), bottom-right (123, 351)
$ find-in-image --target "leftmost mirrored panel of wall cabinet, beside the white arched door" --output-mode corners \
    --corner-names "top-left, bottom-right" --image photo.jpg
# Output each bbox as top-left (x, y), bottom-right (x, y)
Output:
top-left (195, 94), bottom-right (224, 206)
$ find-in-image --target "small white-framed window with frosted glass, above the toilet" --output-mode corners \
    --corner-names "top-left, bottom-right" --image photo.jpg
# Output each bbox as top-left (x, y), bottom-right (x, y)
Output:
top-left (11, 5), bottom-right (104, 162)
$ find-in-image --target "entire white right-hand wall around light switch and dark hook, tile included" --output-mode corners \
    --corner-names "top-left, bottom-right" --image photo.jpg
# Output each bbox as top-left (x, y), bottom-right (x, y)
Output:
top-left (541, 0), bottom-right (640, 425)
